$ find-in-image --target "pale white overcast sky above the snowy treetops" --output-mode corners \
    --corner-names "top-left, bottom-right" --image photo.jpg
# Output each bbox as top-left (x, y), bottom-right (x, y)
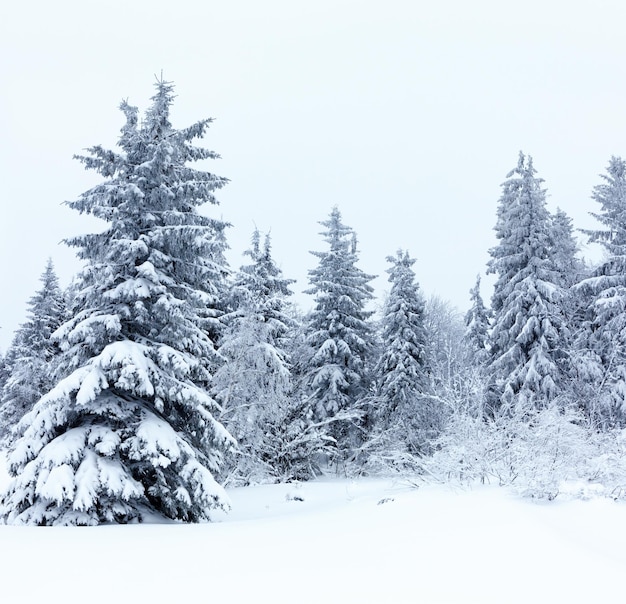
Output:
top-left (0, 0), bottom-right (626, 350)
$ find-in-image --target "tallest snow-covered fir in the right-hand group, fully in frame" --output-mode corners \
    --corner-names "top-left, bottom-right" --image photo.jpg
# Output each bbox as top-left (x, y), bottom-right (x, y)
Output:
top-left (488, 153), bottom-right (568, 408)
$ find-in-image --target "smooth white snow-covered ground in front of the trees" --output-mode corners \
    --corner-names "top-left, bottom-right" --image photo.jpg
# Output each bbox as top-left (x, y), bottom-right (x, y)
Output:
top-left (0, 458), bottom-right (626, 604)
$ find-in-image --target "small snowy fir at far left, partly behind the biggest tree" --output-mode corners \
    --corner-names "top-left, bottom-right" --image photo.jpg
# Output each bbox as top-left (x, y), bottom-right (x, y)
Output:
top-left (0, 260), bottom-right (67, 442)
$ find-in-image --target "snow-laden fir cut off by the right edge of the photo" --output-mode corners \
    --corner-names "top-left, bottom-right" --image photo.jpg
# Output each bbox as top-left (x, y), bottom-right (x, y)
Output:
top-left (576, 157), bottom-right (626, 427)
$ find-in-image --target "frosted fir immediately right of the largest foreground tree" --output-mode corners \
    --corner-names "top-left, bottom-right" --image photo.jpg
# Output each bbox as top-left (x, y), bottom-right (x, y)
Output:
top-left (214, 230), bottom-right (302, 483)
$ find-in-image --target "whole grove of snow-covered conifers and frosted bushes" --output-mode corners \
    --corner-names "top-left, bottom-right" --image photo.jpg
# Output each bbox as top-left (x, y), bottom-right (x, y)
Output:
top-left (0, 81), bottom-right (626, 525)
